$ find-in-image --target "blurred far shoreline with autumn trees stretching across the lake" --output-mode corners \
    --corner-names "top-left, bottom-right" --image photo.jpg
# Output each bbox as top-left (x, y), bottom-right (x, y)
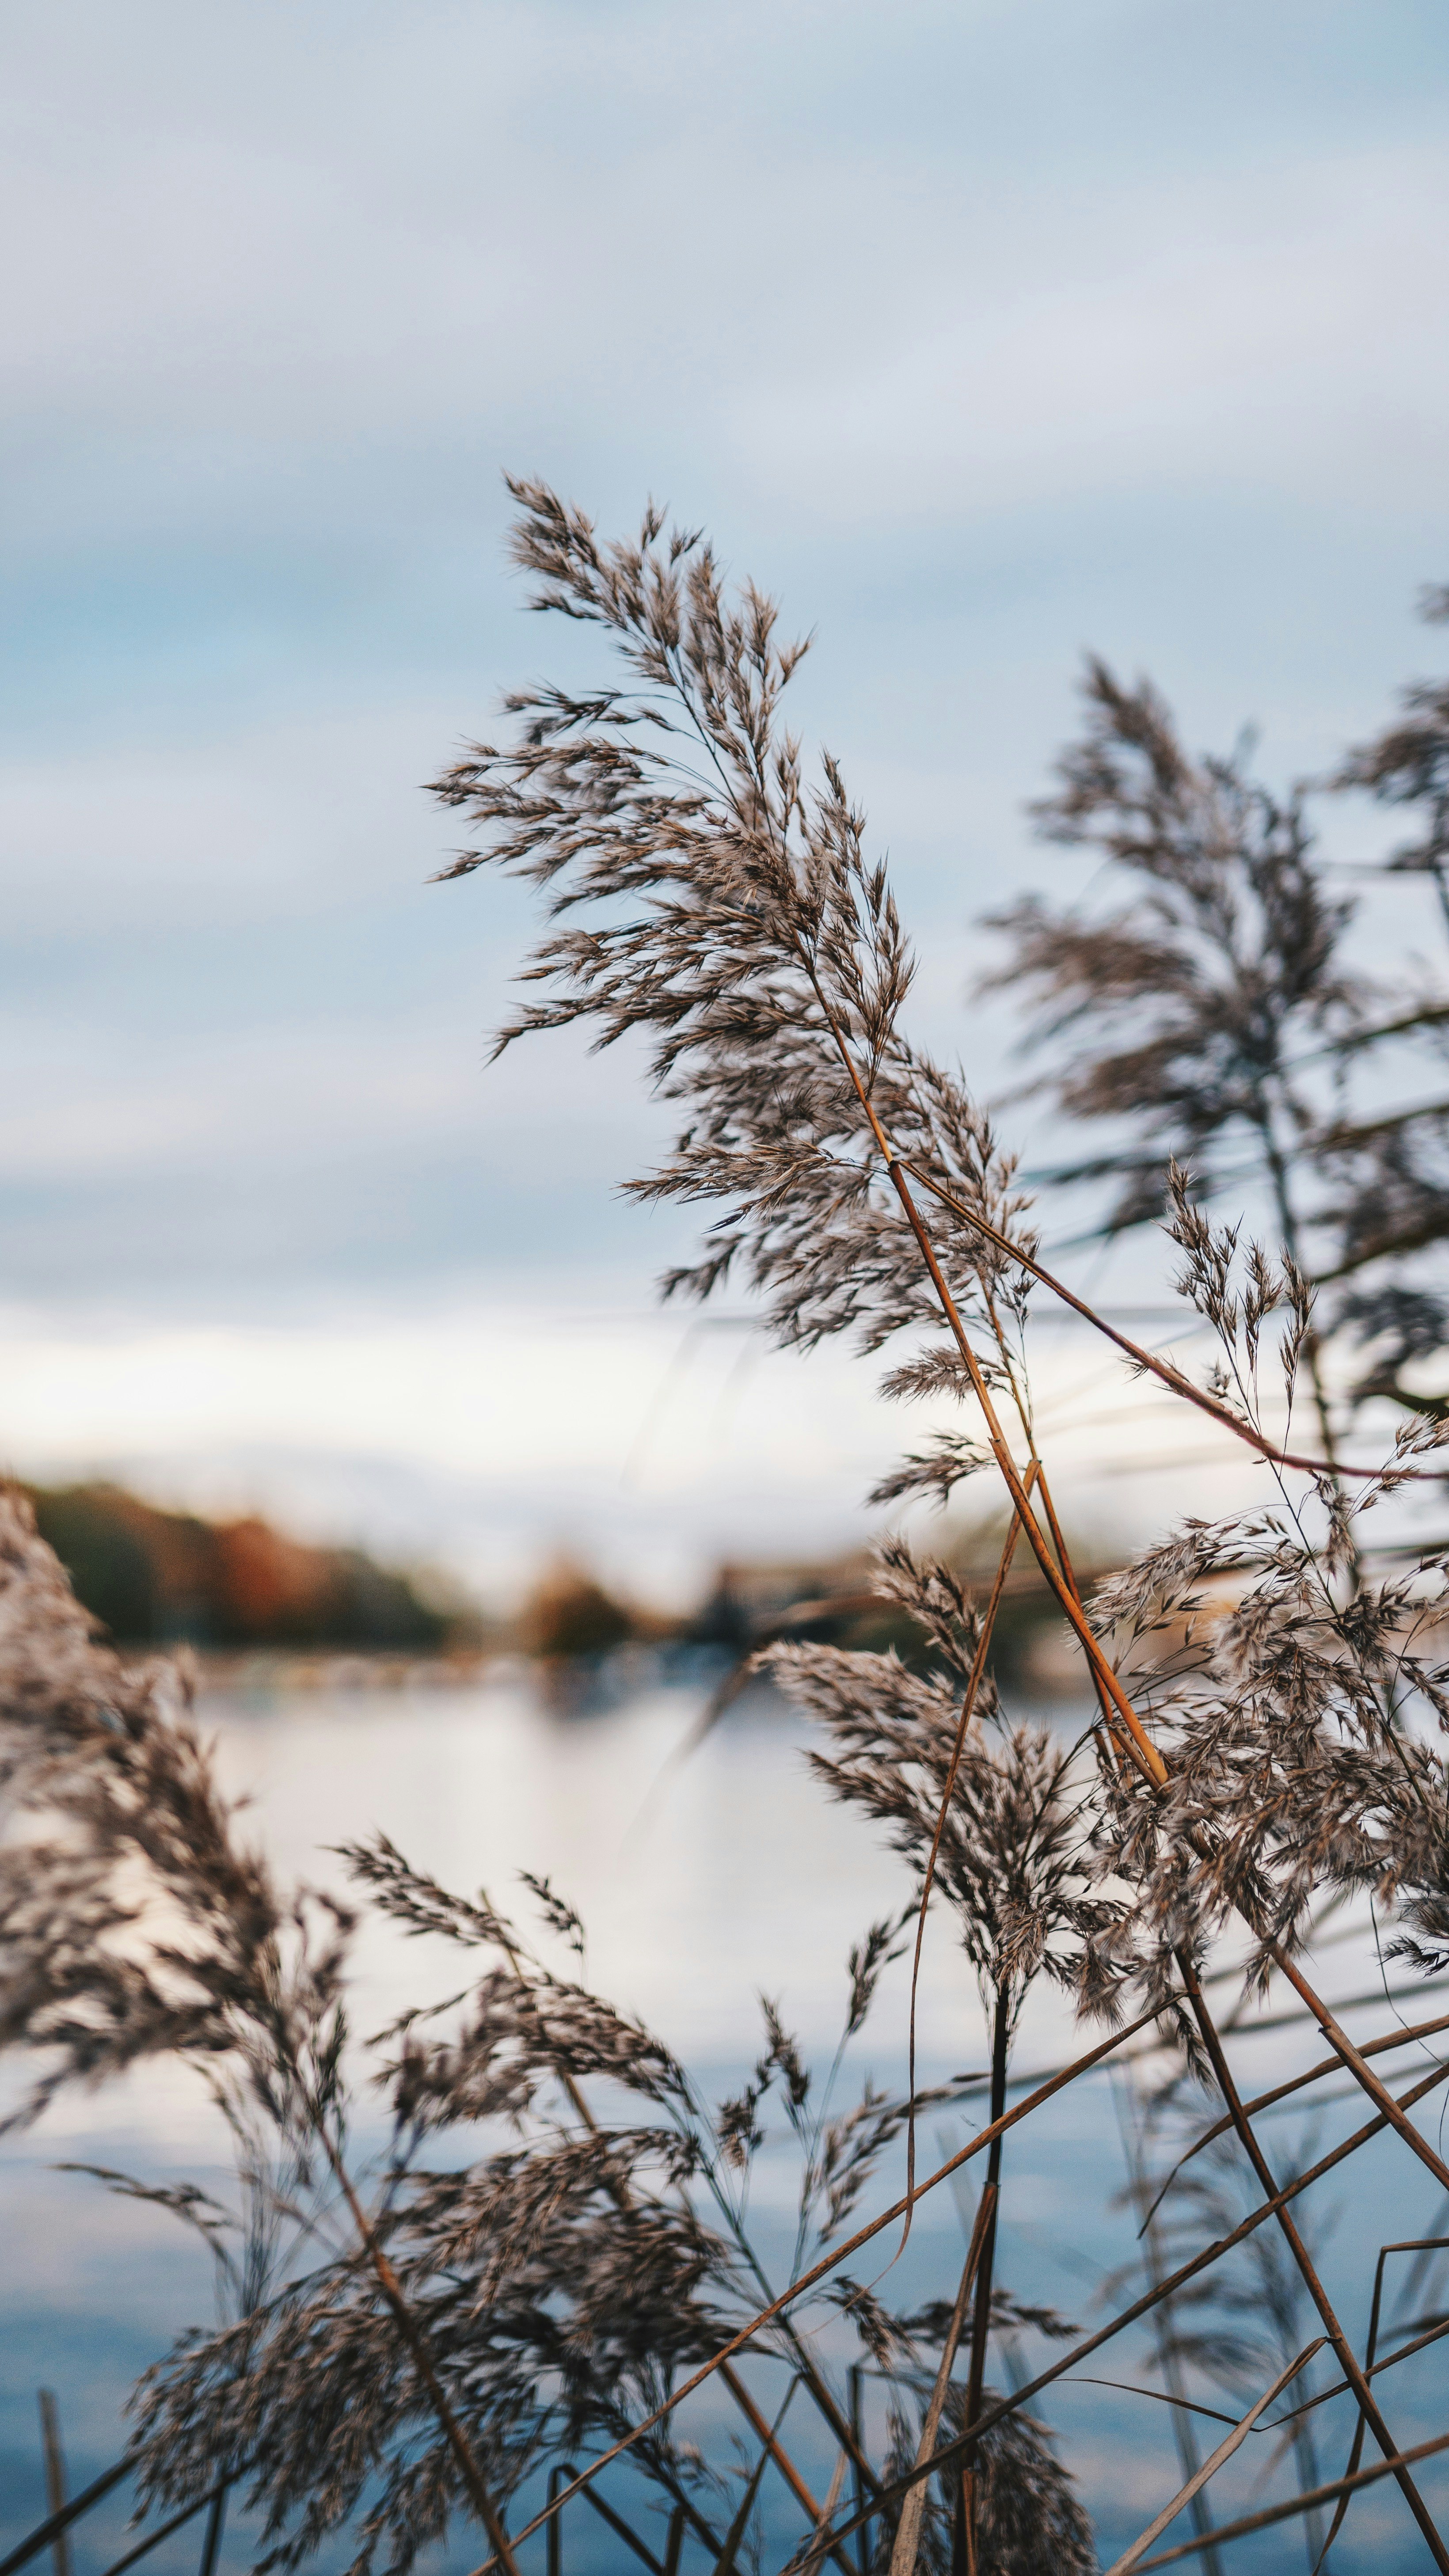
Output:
top-left (39, 1481), bottom-right (1107, 1705)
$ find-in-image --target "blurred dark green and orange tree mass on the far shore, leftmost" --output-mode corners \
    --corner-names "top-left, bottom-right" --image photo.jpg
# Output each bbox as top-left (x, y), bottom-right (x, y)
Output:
top-left (26, 1484), bottom-right (463, 1654)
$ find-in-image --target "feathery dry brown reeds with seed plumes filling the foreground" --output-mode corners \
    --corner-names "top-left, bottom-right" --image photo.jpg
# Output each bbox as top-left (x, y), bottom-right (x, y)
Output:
top-left (0, 484), bottom-right (1449, 2576)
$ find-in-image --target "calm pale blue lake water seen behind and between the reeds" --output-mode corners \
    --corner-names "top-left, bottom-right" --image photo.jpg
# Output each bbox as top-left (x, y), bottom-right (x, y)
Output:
top-left (0, 1674), bottom-right (1449, 2576)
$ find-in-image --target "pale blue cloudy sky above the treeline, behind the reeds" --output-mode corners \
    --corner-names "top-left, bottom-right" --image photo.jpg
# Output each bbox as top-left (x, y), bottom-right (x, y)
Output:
top-left (0, 0), bottom-right (1449, 1597)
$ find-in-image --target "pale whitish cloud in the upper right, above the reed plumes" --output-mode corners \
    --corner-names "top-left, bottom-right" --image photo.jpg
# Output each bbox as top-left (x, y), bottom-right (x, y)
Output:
top-left (736, 149), bottom-right (1449, 523)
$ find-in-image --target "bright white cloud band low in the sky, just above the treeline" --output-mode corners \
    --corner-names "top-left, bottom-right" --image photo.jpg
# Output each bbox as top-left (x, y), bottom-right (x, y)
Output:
top-left (0, 1288), bottom-right (1276, 1600)
